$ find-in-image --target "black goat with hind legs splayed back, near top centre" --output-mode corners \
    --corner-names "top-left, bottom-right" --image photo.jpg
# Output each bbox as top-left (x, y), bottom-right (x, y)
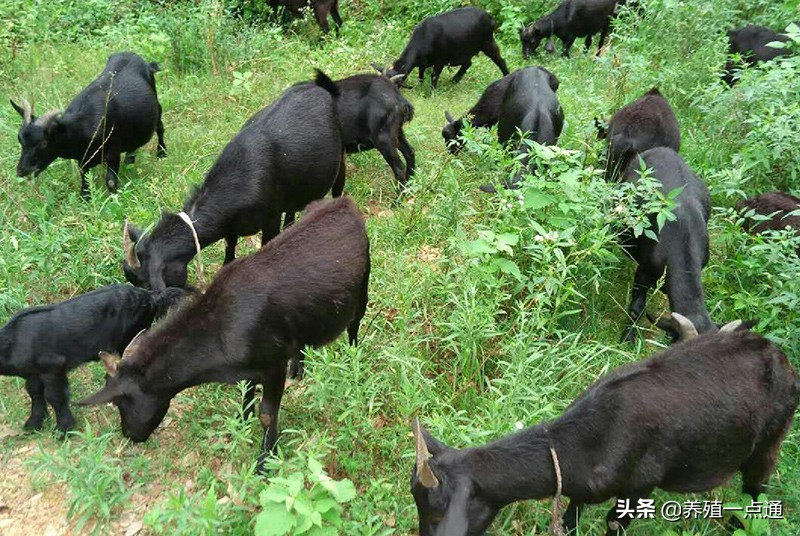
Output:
top-left (378, 7), bottom-right (508, 89)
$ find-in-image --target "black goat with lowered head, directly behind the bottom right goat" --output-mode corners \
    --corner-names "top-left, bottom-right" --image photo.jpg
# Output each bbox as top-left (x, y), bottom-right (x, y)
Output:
top-left (622, 147), bottom-right (717, 342)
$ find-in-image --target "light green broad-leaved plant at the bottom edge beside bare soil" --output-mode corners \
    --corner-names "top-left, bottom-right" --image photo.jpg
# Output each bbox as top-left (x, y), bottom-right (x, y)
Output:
top-left (255, 456), bottom-right (356, 536)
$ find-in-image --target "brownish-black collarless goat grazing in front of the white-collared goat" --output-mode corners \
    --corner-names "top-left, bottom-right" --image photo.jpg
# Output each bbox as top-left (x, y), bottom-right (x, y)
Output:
top-left (81, 197), bottom-right (370, 474)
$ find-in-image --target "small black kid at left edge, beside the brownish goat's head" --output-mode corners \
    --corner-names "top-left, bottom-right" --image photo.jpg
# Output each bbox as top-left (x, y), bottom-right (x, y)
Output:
top-left (0, 285), bottom-right (184, 432)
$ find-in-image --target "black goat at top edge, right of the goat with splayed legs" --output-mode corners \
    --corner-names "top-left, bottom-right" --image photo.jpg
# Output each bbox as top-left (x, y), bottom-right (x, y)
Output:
top-left (520, 0), bottom-right (617, 60)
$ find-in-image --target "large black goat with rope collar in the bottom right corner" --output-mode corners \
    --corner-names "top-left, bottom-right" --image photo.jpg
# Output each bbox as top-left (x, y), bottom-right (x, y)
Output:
top-left (411, 322), bottom-right (800, 536)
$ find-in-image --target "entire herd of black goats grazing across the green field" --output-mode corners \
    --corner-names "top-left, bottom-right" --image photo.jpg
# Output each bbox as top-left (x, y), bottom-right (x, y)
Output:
top-left (0, 0), bottom-right (800, 536)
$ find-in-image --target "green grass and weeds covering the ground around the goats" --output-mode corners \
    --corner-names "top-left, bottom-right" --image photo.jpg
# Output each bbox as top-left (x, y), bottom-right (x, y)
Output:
top-left (0, 0), bottom-right (800, 535)
